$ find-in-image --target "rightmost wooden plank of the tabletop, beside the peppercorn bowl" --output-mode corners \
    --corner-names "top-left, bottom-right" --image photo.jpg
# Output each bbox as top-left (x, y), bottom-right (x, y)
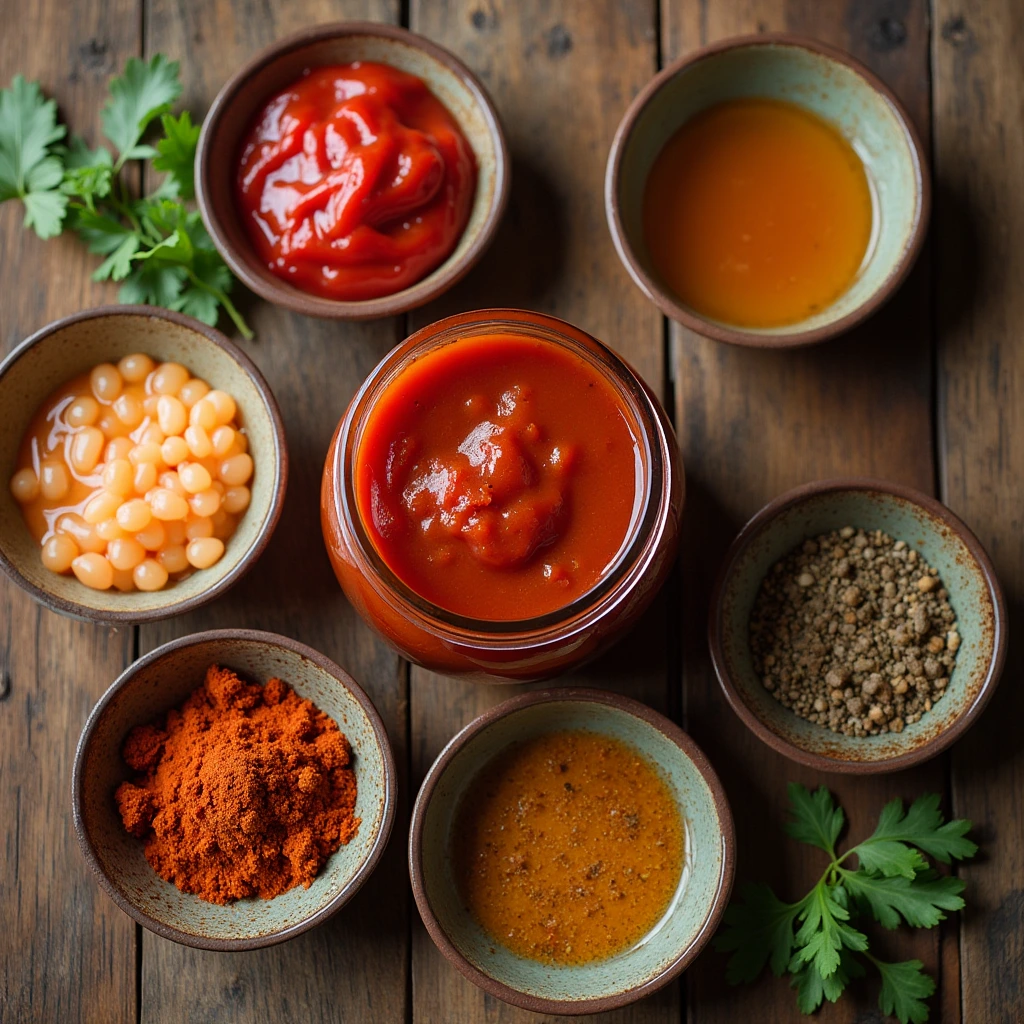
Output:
top-left (932, 0), bottom-right (1024, 1021)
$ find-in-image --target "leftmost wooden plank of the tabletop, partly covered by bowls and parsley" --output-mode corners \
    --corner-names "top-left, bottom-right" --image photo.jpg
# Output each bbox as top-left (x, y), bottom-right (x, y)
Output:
top-left (0, 0), bottom-right (140, 1022)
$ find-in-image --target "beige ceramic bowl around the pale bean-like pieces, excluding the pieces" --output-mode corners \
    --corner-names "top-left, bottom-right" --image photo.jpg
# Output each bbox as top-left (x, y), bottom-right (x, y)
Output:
top-left (0, 306), bottom-right (288, 624)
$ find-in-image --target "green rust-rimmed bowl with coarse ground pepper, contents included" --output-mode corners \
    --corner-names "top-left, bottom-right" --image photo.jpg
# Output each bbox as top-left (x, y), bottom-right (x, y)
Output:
top-left (709, 479), bottom-right (1007, 774)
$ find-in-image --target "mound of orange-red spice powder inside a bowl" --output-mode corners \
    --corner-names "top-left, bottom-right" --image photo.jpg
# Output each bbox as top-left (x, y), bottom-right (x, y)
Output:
top-left (115, 666), bottom-right (359, 903)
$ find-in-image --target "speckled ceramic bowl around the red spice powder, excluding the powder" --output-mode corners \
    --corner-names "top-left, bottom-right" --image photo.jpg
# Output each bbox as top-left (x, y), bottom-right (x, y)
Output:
top-left (72, 630), bottom-right (395, 951)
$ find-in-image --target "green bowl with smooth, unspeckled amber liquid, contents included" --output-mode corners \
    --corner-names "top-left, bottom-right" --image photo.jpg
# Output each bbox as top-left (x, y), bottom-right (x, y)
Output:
top-left (605, 35), bottom-right (931, 348)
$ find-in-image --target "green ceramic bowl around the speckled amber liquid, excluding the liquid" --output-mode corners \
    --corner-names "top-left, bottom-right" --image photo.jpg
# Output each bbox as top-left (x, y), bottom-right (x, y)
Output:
top-left (409, 688), bottom-right (735, 1014)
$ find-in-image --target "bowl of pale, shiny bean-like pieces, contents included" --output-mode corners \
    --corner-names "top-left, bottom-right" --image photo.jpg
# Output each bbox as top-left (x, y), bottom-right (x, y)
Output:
top-left (0, 306), bottom-right (288, 623)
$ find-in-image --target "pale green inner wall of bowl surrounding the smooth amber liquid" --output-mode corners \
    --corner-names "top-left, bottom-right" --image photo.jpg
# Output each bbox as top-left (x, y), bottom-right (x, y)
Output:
top-left (609, 40), bottom-right (927, 344)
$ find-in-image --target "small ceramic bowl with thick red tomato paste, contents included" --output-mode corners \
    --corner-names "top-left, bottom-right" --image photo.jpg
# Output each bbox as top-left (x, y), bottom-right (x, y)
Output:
top-left (196, 22), bottom-right (509, 319)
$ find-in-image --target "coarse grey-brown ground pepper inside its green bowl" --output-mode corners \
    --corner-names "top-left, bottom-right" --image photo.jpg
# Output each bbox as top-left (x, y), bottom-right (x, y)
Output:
top-left (750, 526), bottom-right (961, 736)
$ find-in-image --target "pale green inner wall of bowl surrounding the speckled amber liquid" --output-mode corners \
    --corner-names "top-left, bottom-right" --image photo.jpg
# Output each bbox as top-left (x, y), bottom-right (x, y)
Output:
top-left (411, 698), bottom-right (732, 1013)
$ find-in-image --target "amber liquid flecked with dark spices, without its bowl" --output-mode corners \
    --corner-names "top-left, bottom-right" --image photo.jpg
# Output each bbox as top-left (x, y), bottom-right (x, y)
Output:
top-left (452, 730), bottom-right (684, 965)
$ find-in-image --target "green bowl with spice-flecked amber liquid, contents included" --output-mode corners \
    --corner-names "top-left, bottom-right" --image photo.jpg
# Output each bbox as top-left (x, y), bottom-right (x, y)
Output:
top-left (409, 688), bottom-right (734, 1014)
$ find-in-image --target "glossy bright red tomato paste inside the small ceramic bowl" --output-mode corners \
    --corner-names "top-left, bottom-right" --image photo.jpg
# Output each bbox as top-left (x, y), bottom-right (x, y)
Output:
top-left (237, 62), bottom-right (476, 301)
